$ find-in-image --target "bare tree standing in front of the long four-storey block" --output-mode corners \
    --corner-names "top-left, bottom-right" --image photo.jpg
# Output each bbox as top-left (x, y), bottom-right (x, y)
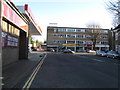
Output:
top-left (87, 23), bottom-right (101, 50)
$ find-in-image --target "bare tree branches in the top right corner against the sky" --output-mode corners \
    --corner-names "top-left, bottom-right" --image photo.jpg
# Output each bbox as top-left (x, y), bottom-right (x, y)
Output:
top-left (107, 0), bottom-right (120, 27)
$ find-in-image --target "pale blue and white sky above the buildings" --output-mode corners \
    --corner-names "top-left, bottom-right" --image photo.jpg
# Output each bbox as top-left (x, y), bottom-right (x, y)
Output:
top-left (11, 0), bottom-right (113, 41)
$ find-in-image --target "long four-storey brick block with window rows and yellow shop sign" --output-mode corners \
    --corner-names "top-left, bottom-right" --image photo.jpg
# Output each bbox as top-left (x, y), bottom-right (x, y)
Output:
top-left (47, 26), bottom-right (109, 51)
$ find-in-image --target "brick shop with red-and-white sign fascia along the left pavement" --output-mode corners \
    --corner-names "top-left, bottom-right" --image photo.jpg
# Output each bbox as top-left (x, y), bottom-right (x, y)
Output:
top-left (0, 0), bottom-right (40, 66)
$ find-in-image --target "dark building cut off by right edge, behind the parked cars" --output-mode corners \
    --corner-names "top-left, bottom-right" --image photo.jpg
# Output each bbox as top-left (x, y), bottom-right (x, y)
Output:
top-left (114, 25), bottom-right (120, 53)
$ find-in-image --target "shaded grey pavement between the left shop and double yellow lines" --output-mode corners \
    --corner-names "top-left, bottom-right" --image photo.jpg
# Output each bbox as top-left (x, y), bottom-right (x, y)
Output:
top-left (2, 51), bottom-right (45, 89)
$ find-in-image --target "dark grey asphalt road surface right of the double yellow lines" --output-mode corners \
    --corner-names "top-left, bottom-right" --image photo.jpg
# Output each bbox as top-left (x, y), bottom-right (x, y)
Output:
top-left (24, 53), bottom-right (119, 88)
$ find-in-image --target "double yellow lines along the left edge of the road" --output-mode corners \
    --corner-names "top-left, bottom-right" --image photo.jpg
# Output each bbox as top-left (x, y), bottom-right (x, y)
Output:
top-left (22, 54), bottom-right (47, 90)
